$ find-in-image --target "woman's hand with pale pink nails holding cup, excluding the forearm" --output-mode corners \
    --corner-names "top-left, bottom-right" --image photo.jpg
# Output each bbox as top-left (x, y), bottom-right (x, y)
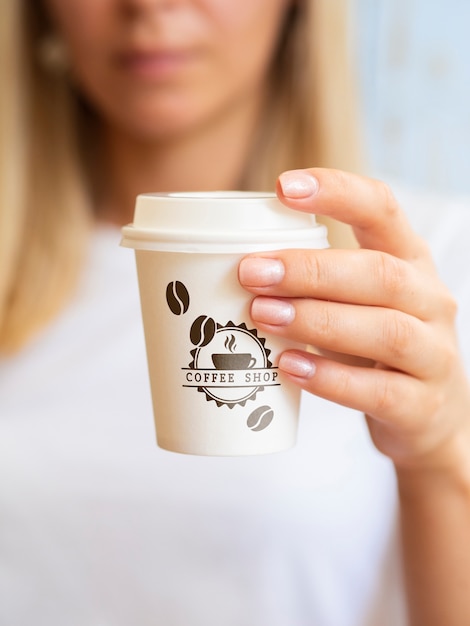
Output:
top-left (239, 169), bottom-right (470, 468)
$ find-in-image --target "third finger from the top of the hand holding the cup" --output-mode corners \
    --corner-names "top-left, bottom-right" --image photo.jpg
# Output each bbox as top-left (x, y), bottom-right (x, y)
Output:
top-left (251, 297), bottom-right (444, 378)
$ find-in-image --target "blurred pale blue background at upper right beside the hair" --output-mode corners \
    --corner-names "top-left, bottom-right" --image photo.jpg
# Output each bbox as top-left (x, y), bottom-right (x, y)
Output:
top-left (351, 0), bottom-right (470, 194)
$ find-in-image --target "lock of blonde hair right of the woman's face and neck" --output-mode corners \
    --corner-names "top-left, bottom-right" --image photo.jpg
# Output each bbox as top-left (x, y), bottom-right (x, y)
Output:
top-left (242, 0), bottom-right (363, 188)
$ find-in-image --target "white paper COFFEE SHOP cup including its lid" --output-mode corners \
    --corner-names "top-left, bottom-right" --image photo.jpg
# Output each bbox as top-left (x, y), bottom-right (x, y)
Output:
top-left (121, 192), bottom-right (328, 456)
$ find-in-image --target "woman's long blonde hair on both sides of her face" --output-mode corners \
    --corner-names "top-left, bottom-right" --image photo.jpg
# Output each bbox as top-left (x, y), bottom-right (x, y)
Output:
top-left (0, 0), bottom-right (364, 351)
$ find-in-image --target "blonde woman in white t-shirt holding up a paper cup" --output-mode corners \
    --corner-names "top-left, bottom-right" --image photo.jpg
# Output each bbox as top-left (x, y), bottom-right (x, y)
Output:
top-left (0, 0), bottom-right (470, 626)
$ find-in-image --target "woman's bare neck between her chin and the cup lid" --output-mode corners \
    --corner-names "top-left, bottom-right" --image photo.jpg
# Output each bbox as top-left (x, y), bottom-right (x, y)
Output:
top-left (97, 90), bottom-right (260, 224)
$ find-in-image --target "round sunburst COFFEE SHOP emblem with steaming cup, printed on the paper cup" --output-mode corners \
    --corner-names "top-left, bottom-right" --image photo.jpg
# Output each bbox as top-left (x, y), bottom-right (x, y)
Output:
top-left (184, 315), bottom-right (279, 409)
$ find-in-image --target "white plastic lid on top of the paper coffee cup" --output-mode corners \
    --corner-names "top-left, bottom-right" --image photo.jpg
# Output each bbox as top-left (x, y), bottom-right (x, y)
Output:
top-left (121, 191), bottom-right (328, 252)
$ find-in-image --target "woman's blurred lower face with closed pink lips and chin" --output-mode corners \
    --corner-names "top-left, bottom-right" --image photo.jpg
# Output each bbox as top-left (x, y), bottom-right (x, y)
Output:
top-left (46, 0), bottom-right (291, 139)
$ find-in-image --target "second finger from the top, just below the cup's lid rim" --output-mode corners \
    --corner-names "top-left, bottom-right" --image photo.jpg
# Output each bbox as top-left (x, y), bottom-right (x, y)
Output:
top-left (239, 250), bottom-right (453, 320)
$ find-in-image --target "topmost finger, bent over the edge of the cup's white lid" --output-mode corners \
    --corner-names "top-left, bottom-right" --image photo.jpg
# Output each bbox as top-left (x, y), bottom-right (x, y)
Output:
top-left (277, 168), bottom-right (429, 260)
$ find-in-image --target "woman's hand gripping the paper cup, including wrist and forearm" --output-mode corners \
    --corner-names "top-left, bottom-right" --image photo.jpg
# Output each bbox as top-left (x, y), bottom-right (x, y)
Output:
top-left (239, 169), bottom-right (470, 626)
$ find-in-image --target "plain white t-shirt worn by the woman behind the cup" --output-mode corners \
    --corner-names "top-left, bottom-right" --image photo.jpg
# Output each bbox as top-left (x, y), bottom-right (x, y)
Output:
top-left (0, 189), bottom-right (470, 626)
